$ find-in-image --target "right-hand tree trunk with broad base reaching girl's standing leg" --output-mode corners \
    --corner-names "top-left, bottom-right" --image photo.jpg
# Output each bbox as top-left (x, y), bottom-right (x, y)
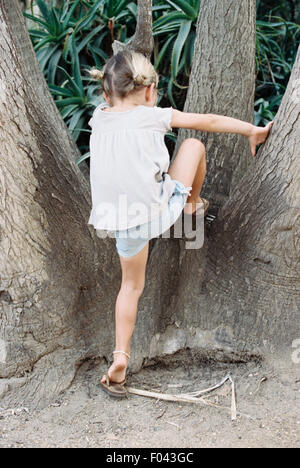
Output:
top-left (129, 46), bottom-right (300, 370)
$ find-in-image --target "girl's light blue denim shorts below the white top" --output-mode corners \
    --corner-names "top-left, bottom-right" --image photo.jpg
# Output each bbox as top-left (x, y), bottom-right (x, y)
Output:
top-left (115, 179), bottom-right (192, 258)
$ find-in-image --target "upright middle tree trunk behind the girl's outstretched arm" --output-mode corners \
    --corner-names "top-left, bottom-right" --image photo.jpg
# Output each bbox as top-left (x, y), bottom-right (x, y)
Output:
top-left (176, 0), bottom-right (256, 211)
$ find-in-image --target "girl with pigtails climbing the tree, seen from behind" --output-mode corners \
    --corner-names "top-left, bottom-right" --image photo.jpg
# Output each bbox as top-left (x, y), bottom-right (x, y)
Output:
top-left (88, 50), bottom-right (272, 398)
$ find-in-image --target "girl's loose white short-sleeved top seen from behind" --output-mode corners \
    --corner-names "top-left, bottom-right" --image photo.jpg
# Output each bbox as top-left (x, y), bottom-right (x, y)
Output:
top-left (88, 103), bottom-right (176, 231)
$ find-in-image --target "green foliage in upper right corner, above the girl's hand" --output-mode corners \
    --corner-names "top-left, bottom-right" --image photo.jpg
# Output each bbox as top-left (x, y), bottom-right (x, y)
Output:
top-left (255, 0), bottom-right (300, 125)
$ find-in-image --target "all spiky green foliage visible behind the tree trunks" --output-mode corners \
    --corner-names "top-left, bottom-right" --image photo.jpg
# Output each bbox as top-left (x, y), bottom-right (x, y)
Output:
top-left (24, 0), bottom-right (300, 164)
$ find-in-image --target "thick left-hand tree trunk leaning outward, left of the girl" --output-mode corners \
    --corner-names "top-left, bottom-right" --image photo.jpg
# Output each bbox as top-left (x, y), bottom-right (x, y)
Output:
top-left (0, 0), bottom-right (121, 406)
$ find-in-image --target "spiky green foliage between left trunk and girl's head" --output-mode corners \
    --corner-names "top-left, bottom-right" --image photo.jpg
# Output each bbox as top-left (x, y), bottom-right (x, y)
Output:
top-left (24, 0), bottom-right (137, 159)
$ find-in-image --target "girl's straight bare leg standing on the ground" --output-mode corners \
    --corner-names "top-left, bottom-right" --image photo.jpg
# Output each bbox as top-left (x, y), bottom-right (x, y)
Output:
top-left (102, 242), bottom-right (149, 382)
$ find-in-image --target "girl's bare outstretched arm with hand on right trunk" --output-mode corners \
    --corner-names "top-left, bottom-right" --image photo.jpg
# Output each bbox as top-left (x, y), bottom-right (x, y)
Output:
top-left (171, 109), bottom-right (273, 156)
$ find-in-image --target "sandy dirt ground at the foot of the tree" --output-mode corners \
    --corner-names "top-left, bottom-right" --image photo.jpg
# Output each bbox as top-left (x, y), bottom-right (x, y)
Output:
top-left (0, 350), bottom-right (300, 448)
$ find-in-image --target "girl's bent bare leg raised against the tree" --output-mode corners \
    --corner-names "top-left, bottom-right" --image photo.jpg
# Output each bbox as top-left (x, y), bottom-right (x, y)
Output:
top-left (168, 138), bottom-right (206, 214)
